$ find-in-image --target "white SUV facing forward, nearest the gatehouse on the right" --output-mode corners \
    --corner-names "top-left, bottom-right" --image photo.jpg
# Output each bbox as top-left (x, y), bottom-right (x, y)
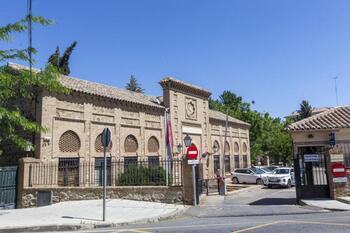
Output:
top-left (267, 167), bottom-right (295, 188)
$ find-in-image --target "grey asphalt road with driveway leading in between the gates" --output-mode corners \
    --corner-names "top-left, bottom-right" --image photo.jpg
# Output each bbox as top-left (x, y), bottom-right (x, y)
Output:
top-left (60, 186), bottom-right (350, 233)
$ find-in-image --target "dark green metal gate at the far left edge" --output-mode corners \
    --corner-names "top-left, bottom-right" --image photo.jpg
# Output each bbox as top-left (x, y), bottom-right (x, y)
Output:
top-left (0, 167), bottom-right (17, 209)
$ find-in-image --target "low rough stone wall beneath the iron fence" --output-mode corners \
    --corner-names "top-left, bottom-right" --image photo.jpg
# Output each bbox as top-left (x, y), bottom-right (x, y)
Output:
top-left (17, 186), bottom-right (183, 208)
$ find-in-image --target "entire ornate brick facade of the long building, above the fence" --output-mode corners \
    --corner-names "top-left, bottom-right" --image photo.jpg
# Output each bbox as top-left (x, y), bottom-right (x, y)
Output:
top-left (20, 74), bottom-right (250, 178)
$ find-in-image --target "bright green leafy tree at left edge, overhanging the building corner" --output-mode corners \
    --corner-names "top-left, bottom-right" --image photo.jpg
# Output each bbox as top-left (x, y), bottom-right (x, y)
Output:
top-left (0, 16), bottom-right (67, 150)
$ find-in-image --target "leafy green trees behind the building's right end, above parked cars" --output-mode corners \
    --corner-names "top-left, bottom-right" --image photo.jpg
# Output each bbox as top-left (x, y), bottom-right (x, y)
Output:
top-left (209, 91), bottom-right (292, 163)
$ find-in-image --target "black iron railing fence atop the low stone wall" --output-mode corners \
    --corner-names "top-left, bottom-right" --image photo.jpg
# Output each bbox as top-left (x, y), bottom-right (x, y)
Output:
top-left (27, 157), bottom-right (182, 187)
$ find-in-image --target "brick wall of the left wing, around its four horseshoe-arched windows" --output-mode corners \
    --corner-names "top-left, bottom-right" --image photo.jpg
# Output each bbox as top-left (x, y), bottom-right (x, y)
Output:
top-left (36, 92), bottom-right (165, 160)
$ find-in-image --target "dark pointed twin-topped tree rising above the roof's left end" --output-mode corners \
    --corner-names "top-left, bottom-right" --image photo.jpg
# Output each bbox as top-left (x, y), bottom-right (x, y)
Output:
top-left (48, 41), bottom-right (77, 75)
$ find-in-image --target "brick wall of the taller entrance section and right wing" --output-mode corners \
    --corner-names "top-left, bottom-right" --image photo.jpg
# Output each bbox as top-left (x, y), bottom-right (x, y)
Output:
top-left (163, 85), bottom-right (251, 178)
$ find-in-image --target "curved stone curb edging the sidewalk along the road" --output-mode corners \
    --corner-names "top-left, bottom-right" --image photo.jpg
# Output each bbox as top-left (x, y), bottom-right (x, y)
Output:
top-left (0, 206), bottom-right (189, 233)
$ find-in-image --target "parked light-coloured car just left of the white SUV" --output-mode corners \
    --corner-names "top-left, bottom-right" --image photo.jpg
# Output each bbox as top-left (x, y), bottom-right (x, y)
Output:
top-left (231, 168), bottom-right (264, 184)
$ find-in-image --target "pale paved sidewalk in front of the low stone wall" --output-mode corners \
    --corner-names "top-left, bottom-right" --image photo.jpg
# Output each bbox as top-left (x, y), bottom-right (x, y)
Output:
top-left (0, 199), bottom-right (188, 232)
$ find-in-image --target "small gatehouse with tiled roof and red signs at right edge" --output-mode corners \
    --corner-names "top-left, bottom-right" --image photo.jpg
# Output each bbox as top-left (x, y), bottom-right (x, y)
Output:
top-left (287, 107), bottom-right (350, 202)
